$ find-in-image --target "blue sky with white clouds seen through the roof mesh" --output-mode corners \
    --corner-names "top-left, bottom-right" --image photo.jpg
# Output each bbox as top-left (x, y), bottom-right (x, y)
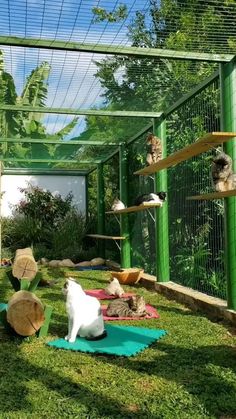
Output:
top-left (0, 0), bottom-right (148, 135)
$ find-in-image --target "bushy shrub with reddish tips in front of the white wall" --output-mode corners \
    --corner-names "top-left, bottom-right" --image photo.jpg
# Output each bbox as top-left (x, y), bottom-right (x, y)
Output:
top-left (2, 185), bottom-right (85, 260)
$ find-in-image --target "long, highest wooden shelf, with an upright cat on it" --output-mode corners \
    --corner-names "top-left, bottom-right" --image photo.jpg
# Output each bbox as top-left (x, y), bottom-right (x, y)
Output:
top-left (134, 132), bottom-right (236, 176)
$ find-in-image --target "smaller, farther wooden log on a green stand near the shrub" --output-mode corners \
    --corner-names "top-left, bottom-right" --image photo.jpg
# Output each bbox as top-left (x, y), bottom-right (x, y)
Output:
top-left (12, 247), bottom-right (38, 281)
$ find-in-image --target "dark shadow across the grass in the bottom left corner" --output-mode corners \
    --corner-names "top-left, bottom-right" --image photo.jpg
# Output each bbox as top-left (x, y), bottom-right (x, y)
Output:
top-left (0, 343), bottom-right (159, 419)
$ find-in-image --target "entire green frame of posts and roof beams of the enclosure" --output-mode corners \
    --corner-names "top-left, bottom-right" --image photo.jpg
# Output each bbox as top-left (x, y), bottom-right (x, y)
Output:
top-left (0, 37), bottom-right (236, 310)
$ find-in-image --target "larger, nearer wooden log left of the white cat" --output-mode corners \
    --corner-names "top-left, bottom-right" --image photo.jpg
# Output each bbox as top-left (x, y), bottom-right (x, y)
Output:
top-left (7, 291), bottom-right (45, 336)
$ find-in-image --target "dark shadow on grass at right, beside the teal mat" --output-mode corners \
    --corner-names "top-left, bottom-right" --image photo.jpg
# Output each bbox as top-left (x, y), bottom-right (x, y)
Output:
top-left (101, 341), bottom-right (236, 417)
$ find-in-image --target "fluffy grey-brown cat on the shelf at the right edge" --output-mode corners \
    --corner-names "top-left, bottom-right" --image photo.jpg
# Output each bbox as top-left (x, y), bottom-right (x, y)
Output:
top-left (211, 152), bottom-right (236, 192)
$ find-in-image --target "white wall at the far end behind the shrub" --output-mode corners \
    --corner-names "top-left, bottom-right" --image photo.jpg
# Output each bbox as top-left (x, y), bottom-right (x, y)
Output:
top-left (1, 175), bottom-right (86, 217)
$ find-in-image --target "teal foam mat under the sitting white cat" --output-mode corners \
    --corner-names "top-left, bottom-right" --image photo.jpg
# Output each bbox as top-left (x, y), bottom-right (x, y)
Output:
top-left (47, 324), bottom-right (167, 356)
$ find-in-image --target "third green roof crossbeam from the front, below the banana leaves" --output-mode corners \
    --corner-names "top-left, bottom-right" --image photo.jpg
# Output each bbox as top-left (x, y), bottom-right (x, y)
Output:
top-left (0, 137), bottom-right (120, 146)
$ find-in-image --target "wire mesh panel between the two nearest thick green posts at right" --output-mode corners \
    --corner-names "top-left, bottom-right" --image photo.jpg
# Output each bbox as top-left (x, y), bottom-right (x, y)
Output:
top-left (167, 82), bottom-right (226, 298)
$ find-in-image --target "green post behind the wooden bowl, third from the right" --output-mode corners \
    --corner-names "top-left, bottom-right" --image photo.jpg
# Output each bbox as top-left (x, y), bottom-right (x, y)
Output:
top-left (119, 144), bottom-right (131, 268)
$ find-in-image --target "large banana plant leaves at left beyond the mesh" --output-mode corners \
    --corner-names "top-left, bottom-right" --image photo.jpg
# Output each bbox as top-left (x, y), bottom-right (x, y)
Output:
top-left (0, 51), bottom-right (78, 164)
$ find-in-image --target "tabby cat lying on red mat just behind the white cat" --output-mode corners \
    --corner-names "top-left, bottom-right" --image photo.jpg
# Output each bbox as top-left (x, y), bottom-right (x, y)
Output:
top-left (107, 295), bottom-right (147, 317)
